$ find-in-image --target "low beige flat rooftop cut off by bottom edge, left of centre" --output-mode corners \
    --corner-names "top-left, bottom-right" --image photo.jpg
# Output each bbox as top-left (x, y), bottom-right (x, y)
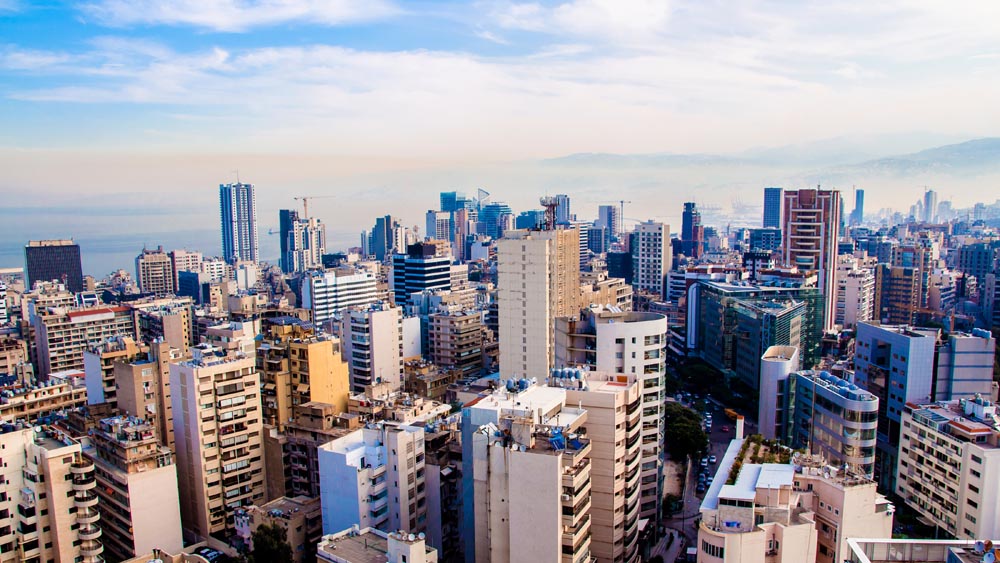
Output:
top-left (316, 528), bottom-right (438, 563)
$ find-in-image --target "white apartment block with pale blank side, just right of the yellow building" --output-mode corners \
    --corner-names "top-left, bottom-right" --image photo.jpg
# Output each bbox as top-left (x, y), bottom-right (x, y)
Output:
top-left (340, 302), bottom-right (404, 393)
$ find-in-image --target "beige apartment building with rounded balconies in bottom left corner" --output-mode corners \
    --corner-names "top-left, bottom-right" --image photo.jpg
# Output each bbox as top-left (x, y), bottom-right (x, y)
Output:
top-left (0, 427), bottom-right (104, 563)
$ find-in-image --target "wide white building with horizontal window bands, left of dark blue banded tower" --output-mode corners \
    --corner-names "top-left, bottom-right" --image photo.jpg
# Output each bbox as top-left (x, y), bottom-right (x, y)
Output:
top-left (302, 268), bottom-right (378, 325)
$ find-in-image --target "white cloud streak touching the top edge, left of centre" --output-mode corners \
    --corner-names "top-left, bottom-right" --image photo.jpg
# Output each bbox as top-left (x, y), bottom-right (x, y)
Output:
top-left (79, 0), bottom-right (399, 32)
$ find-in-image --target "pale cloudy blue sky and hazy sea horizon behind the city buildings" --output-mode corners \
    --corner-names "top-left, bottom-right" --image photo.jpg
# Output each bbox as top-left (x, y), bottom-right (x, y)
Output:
top-left (0, 0), bottom-right (1000, 274)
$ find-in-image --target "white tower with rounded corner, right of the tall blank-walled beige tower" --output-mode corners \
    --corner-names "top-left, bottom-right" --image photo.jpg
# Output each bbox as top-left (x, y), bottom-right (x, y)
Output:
top-left (555, 307), bottom-right (667, 519)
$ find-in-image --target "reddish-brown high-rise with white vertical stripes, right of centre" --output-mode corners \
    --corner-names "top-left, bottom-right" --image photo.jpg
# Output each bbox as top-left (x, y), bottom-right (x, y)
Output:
top-left (781, 188), bottom-right (840, 331)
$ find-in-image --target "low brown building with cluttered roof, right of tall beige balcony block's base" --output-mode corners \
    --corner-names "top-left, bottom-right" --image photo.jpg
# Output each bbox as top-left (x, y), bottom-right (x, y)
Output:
top-left (236, 497), bottom-right (323, 563)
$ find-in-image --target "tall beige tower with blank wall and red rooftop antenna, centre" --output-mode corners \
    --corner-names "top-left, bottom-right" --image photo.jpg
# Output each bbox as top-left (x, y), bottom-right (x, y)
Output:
top-left (497, 229), bottom-right (580, 379)
